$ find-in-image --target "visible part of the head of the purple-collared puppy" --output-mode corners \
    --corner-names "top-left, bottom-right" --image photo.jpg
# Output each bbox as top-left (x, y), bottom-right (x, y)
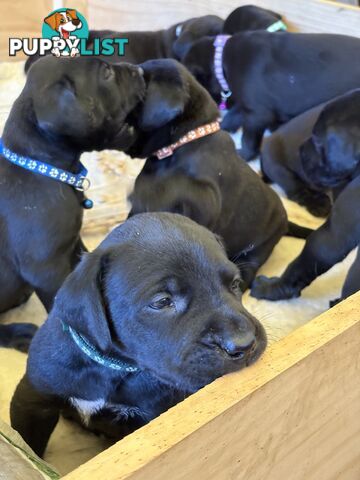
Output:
top-left (182, 37), bottom-right (221, 103)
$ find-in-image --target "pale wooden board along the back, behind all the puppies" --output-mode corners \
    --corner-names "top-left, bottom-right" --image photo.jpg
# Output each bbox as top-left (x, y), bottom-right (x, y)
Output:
top-left (88, 0), bottom-right (360, 36)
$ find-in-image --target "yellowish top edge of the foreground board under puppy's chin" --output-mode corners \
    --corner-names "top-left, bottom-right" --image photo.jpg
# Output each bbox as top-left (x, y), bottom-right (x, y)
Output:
top-left (64, 292), bottom-right (360, 480)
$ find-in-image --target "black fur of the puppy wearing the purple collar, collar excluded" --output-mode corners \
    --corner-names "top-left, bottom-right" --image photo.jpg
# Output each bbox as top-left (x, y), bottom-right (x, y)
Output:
top-left (183, 31), bottom-right (360, 160)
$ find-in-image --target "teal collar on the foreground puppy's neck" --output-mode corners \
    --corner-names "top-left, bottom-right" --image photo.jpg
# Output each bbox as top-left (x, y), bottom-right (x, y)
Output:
top-left (61, 322), bottom-right (139, 373)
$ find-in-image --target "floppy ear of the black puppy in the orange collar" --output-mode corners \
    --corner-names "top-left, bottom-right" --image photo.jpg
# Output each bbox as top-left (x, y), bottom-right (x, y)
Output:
top-left (139, 79), bottom-right (187, 130)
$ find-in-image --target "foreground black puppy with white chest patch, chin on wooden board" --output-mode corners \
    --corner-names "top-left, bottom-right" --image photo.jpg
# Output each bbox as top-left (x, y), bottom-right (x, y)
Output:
top-left (11, 213), bottom-right (266, 455)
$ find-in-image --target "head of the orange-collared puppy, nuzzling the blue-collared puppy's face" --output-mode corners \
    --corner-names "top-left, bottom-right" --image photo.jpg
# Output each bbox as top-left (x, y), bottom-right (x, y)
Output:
top-left (127, 59), bottom-right (219, 157)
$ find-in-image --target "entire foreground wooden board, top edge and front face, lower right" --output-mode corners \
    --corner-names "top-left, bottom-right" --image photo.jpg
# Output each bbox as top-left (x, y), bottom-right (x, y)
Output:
top-left (64, 292), bottom-right (360, 480)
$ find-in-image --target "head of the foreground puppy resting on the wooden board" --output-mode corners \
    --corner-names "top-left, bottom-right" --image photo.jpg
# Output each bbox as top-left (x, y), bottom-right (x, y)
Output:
top-left (51, 213), bottom-right (266, 392)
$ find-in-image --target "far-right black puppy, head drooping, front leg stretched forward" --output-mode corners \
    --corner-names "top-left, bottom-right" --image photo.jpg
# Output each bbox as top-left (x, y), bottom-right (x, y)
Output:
top-left (251, 89), bottom-right (360, 300)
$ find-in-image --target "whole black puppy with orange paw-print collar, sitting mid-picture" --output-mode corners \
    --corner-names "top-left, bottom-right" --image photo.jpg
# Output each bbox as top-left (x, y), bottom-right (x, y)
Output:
top-left (127, 60), bottom-right (309, 290)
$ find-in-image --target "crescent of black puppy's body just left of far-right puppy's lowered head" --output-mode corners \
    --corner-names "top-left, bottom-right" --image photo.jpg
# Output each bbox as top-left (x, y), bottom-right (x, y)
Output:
top-left (260, 104), bottom-right (331, 217)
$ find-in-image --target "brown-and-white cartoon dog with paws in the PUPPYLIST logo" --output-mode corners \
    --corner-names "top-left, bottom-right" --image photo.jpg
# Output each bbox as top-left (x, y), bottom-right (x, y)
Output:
top-left (44, 8), bottom-right (82, 57)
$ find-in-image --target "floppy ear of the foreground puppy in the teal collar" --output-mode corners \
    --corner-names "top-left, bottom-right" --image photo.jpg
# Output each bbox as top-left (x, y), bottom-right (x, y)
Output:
top-left (51, 252), bottom-right (112, 352)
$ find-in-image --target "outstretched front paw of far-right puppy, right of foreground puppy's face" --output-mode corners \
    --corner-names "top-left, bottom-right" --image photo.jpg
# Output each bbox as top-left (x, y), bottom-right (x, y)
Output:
top-left (251, 275), bottom-right (300, 301)
